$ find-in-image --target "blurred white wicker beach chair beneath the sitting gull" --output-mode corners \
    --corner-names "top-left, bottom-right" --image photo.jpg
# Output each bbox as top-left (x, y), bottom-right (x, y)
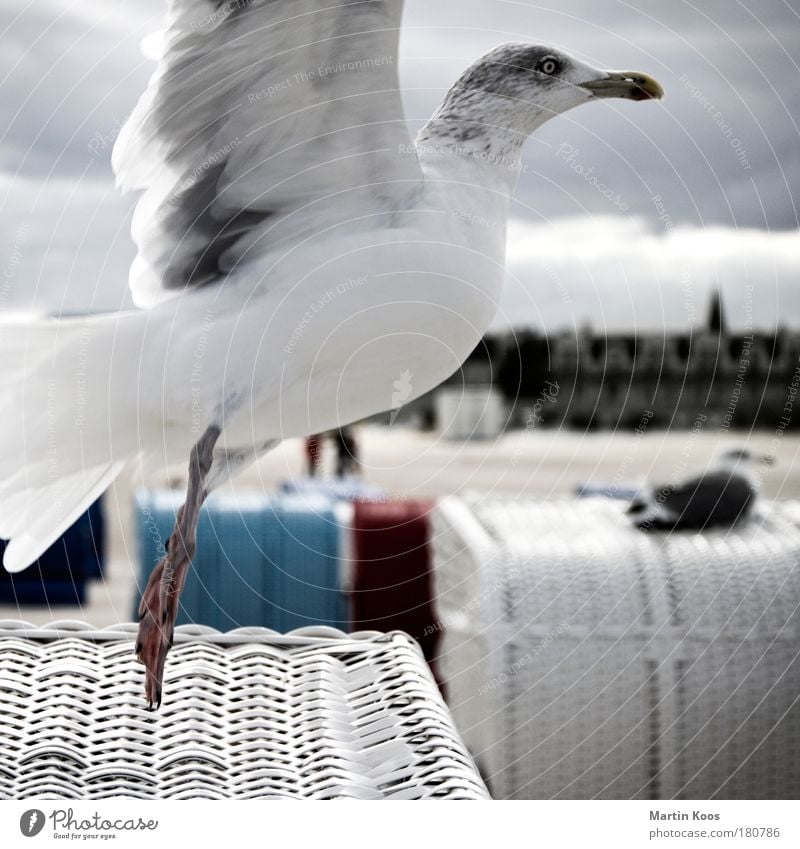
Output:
top-left (433, 496), bottom-right (800, 799)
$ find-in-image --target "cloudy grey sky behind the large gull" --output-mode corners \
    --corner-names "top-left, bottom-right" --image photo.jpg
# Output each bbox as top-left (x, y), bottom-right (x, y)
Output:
top-left (0, 0), bottom-right (800, 329)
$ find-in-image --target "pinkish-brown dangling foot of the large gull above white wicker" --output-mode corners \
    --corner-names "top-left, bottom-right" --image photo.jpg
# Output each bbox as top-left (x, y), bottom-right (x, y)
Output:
top-left (136, 554), bottom-right (184, 710)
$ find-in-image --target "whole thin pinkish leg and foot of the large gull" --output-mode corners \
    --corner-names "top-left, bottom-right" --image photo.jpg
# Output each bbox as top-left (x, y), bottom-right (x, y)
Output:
top-left (136, 425), bottom-right (220, 708)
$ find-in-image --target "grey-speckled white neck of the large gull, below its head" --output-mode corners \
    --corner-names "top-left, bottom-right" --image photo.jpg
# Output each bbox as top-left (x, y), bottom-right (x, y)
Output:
top-left (416, 83), bottom-right (551, 197)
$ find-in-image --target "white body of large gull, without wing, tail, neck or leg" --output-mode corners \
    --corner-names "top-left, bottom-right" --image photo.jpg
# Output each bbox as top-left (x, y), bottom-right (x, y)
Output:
top-left (144, 188), bottom-right (505, 445)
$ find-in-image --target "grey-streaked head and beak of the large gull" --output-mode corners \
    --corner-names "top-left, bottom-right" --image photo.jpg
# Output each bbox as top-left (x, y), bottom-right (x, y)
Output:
top-left (434, 43), bottom-right (664, 151)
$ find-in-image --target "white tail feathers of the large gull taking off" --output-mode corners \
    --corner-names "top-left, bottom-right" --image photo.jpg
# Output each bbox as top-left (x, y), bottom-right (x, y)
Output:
top-left (0, 316), bottom-right (138, 572)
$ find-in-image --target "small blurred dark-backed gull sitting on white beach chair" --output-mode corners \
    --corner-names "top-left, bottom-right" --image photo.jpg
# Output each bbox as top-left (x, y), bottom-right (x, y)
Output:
top-left (628, 448), bottom-right (773, 531)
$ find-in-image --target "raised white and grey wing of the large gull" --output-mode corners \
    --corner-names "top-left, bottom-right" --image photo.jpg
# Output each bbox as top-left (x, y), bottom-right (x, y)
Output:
top-left (112, 0), bottom-right (421, 305)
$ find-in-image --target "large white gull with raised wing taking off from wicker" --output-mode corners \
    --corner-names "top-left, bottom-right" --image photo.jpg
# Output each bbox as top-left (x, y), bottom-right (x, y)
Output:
top-left (0, 0), bottom-right (663, 708)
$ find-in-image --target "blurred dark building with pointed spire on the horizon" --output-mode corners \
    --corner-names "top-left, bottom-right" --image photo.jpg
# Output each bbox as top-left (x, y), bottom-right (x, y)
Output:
top-left (390, 293), bottom-right (800, 438)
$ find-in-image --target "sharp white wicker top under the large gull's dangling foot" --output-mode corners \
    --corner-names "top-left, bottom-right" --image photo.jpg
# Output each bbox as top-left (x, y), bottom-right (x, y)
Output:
top-left (0, 622), bottom-right (487, 799)
